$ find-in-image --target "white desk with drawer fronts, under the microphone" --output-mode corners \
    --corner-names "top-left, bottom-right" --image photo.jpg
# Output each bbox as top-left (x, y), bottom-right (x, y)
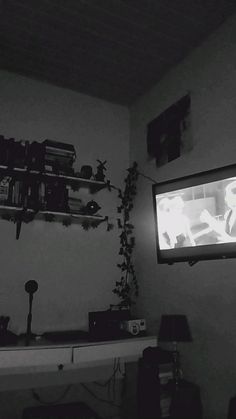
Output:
top-left (0, 336), bottom-right (157, 391)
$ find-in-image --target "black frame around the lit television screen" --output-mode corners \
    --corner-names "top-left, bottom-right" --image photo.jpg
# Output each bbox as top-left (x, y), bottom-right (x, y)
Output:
top-left (152, 164), bottom-right (236, 265)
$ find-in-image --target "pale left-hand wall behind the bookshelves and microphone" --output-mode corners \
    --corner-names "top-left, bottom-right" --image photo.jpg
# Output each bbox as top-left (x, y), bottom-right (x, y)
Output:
top-left (0, 71), bottom-right (129, 333)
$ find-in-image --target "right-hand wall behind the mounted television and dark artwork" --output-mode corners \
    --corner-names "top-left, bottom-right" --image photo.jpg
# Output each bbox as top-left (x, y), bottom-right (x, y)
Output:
top-left (131, 11), bottom-right (236, 419)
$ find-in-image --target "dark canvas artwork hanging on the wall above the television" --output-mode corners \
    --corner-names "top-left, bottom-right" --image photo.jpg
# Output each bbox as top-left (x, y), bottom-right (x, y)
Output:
top-left (147, 95), bottom-right (192, 166)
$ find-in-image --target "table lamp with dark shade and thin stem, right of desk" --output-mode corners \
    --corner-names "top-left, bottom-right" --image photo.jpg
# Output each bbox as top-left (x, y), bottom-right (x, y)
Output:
top-left (158, 314), bottom-right (192, 387)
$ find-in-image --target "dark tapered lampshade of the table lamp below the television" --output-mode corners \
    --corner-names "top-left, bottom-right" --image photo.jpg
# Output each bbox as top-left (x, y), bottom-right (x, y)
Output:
top-left (158, 314), bottom-right (192, 342)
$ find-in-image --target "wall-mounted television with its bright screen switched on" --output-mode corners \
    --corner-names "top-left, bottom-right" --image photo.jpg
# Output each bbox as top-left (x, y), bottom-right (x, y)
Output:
top-left (153, 164), bottom-right (236, 265)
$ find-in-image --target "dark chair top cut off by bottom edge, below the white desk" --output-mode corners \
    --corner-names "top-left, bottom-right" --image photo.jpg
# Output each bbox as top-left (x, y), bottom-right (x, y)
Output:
top-left (22, 402), bottom-right (100, 419)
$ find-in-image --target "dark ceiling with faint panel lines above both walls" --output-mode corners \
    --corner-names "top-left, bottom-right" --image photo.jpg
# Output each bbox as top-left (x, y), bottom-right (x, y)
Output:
top-left (0, 0), bottom-right (236, 105)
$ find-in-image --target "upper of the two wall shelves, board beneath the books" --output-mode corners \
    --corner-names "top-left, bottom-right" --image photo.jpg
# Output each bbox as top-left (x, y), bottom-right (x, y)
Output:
top-left (0, 165), bottom-right (107, 193)
